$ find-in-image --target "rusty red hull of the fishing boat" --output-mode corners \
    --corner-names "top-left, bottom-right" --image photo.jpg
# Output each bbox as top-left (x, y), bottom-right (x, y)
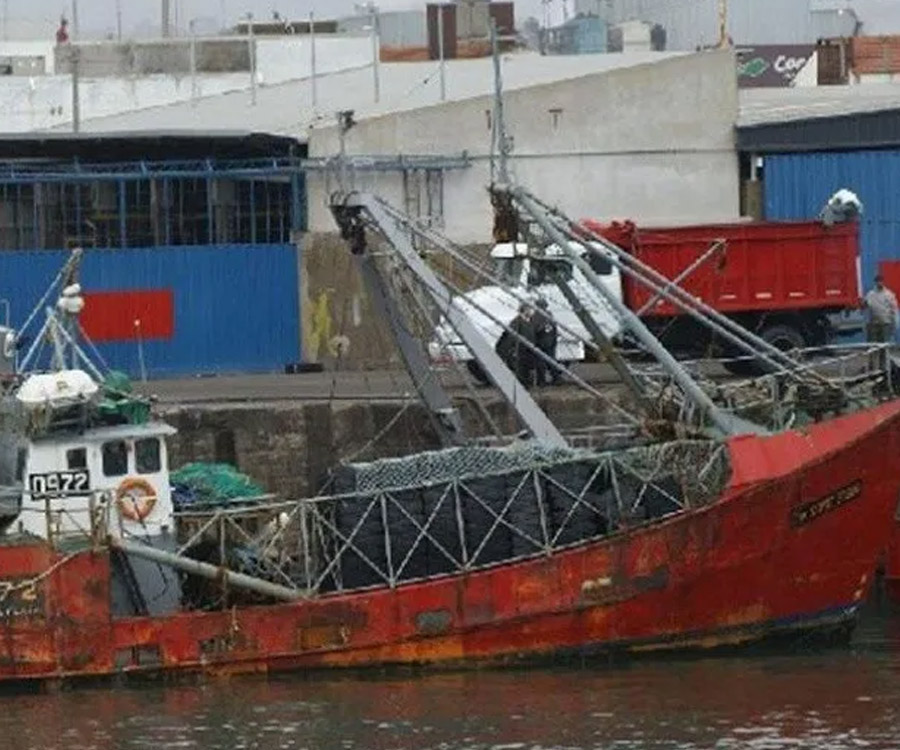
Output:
top-left (0, 402), bottom-right (900, 680)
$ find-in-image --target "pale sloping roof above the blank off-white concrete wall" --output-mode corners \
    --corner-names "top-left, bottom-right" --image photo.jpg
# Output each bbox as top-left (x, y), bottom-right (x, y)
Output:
top-left (54, 52), bottom-right (684, 138)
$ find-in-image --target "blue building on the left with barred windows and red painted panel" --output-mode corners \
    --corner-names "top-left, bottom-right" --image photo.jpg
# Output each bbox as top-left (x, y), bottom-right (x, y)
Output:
top-left (0, 134), bottom-right (305, 378)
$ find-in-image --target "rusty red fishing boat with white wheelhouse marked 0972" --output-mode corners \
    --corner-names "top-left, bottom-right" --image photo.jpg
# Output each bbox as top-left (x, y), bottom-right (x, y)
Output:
top-left (0, 29), bottom-right (900, 682)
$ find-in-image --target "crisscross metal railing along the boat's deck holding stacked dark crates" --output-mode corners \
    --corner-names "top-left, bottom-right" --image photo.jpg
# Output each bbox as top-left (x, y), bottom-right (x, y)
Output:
top-left (169, 441), bottom-right (730, 597)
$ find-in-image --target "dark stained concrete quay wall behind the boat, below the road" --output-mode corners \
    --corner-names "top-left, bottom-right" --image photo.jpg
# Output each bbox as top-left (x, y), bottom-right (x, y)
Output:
top-left (162, 387), bottom-right (623, 498)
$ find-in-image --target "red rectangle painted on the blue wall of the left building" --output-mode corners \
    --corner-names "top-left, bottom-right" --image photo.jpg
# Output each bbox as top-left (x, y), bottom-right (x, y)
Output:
top-left (81, 289), bottom-right (175, 341)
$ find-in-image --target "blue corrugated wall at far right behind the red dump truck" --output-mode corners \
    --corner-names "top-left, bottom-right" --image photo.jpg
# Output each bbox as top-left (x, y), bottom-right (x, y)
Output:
top-left (764, 150), bottom-right (900, 288)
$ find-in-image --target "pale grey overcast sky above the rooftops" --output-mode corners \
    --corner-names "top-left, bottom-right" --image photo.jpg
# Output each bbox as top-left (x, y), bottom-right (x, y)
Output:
top-left (0, 0), bottom-right (900, 37)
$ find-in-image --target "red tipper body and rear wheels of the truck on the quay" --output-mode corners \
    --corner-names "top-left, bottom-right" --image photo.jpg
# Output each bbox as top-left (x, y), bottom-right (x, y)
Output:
top-left (584, 220), bottom-right (862, 364)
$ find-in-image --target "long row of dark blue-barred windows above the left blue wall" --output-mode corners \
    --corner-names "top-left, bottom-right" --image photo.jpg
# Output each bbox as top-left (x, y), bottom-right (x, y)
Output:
top-left (0, 160), bottom-right (305, 250)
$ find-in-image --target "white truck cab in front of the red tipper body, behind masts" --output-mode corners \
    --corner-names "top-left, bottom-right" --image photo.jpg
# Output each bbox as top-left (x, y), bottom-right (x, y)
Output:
top-left (429, 243), bottom-right (622, 374)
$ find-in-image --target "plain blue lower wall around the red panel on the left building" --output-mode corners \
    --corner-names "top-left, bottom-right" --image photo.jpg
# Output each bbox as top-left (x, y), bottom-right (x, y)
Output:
top-left (0, 245), bottom-right (300, 378)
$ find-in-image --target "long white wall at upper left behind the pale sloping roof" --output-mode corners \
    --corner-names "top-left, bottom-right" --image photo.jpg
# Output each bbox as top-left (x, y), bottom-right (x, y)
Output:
top-left (0, 37), bottom-right (372, 133)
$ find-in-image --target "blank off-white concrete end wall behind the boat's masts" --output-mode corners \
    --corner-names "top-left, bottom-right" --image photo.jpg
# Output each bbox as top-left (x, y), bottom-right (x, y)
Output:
top-left (308, 50), bottom-right (739, 242)
